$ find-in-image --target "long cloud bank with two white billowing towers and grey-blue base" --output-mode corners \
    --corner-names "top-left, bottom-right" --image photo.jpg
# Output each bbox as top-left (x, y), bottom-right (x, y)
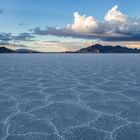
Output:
top-left (34, 5), bottom-right (140, 41)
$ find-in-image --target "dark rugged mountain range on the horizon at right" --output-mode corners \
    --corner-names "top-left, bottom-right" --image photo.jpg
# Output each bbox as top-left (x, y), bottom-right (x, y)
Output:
top-left (67, 44), bottom-right (140, 53)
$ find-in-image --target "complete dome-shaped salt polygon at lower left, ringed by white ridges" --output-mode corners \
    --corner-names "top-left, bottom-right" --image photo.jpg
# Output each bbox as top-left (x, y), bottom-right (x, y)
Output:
top-left (8, 113), bottom-right (55, 135)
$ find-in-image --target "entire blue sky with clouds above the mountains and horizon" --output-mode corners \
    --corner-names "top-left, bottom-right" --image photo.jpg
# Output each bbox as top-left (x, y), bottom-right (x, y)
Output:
top-left (0, 0), bottom-right (140, 52)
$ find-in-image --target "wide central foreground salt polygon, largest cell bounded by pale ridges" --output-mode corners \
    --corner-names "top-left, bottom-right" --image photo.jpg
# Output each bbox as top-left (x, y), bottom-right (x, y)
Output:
top-left (30, 103), bottom-right (98, 128)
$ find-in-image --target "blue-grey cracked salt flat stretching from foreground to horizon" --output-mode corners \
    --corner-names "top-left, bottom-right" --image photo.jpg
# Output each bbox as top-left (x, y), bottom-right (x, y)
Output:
top-left (0, 54), bottom-right (140, 140)
